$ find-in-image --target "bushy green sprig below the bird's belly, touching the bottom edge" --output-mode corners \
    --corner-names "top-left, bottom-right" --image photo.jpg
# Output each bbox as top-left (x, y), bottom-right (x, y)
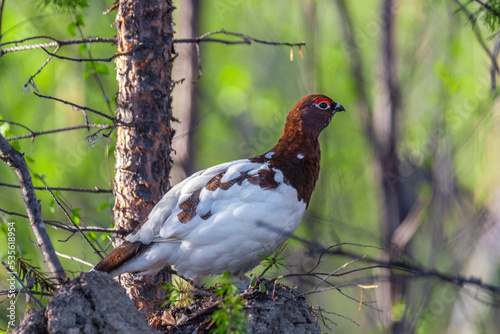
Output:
top-left (211, 272), bottom-right (248, 334)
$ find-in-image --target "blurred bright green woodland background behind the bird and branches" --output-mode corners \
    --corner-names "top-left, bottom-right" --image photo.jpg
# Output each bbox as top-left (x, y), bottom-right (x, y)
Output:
top-left (0, 0), bottom-right (500, 333)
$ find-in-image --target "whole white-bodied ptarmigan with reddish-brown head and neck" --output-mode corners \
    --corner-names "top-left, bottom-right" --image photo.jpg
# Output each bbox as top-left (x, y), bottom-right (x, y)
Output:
top-left (94, 94), bottom-right (344, 278)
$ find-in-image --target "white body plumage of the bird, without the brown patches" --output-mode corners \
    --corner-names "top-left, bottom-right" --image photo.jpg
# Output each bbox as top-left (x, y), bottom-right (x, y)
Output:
top-left (110, 159), bottom-right (306, 278)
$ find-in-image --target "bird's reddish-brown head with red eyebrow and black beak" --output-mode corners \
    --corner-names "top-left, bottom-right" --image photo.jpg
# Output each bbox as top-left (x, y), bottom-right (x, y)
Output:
top-left (285, 94), bottom-right (345, 136)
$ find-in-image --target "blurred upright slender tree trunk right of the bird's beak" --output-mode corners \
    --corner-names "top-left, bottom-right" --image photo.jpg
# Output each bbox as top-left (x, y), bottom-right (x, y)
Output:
top-left (373, 0), bottom-right (407, 333)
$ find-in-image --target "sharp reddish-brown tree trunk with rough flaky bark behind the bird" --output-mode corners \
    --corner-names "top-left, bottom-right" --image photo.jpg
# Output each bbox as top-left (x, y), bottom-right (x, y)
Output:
top-left (114, 0), bottom-right (174, 315)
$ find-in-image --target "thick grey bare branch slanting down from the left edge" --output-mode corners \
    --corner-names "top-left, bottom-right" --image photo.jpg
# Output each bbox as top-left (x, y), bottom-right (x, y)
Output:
top-left (0, 135), bottom-right (66, 278)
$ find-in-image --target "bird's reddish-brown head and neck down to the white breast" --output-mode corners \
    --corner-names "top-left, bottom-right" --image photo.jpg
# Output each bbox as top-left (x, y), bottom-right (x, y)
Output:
top-left (251, 94), bottom-right (344, 206)
